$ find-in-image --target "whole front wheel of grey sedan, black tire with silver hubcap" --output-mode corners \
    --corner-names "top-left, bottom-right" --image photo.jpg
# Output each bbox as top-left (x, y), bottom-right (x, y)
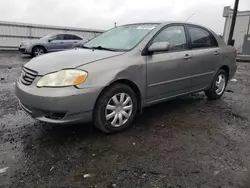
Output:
top-left (93, 83), bottom-right (138, 133)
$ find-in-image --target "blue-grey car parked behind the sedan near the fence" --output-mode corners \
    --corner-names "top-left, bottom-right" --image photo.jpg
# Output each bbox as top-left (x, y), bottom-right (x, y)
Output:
top-left (19, 33), bottom-right (86, 57)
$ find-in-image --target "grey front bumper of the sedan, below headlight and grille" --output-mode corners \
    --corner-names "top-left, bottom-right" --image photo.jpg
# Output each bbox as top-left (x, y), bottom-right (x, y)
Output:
top-left (16, 81), bottom-right (101, 124)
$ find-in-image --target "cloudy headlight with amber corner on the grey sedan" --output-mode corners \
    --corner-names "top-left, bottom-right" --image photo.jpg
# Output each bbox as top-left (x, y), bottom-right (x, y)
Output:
top-left (36, 69), bottom-right (88, 87)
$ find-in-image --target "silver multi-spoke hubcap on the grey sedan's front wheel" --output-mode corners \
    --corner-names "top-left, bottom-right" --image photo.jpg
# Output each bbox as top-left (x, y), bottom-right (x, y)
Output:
top-left (105, 93), bottom-right (133, 127)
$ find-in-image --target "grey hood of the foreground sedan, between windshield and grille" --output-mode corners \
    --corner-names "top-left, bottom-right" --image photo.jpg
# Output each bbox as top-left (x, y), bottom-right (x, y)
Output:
top-left (24, 49), bottom-right (125, 75)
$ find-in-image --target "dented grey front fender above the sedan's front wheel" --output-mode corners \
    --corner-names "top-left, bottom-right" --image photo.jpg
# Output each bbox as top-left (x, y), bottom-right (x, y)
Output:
top-left (77, 56), bottom-right (146, 98)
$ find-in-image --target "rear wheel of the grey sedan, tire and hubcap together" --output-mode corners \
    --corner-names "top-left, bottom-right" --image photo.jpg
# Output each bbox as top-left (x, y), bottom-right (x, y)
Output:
top-left (205, 69), bottom-right (228, 100)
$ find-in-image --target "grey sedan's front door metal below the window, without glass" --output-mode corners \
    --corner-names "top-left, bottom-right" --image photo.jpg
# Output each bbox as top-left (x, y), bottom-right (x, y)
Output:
top-left (147, 51), bottom-right (193, 102)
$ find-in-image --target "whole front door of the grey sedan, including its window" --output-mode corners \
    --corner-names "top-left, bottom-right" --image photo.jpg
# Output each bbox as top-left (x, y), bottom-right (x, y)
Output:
top-left (147, 25), bottom-right (192, 103)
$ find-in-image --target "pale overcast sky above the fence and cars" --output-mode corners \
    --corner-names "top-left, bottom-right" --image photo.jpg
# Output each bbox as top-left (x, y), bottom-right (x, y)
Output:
top-left (0, 0), bottom-right (250, 34)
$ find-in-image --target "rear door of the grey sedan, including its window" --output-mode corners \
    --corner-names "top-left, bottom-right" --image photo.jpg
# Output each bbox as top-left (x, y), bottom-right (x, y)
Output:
top-left (187, 26), bottom-right (220, 90)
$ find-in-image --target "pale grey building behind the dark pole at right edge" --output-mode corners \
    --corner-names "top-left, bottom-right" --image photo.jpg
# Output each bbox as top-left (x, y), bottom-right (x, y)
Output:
top-left (223, 6), bottom-right (250, 55)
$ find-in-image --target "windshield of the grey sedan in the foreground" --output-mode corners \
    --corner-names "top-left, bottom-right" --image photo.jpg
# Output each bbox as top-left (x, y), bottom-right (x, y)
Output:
top-left (84, 24), bottom-right (158, 51)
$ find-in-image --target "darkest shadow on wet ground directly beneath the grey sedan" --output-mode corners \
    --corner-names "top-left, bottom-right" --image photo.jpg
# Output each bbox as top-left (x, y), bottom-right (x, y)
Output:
top-left (22, 94), bottom-right (207, 148)
